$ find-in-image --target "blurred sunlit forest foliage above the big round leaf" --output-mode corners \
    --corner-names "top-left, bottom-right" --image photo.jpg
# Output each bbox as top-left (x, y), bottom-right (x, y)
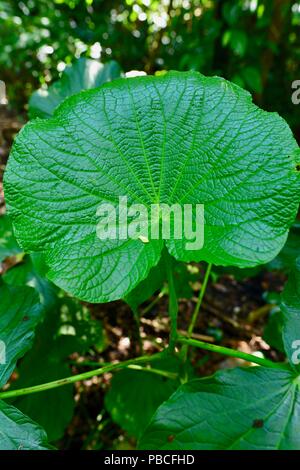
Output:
top-left (0, 0), bottom-right (300, 138)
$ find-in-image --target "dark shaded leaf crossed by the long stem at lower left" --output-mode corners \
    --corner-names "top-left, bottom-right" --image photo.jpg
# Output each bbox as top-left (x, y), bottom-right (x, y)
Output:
top-left (11, 296), bottom-right (104, 442)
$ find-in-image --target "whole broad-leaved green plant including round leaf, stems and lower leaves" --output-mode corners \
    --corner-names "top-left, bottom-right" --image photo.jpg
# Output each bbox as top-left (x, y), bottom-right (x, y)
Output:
top-left (0, 64), bottom-right (300, 450)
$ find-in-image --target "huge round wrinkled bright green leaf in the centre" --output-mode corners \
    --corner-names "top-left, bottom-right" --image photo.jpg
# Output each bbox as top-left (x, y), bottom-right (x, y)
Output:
top-left (5, 72), bottom-right (300, 302)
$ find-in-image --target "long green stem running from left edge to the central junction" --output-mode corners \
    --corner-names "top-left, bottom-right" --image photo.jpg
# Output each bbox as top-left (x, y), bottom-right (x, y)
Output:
top-left (0, 352), bottom-right (163, 398)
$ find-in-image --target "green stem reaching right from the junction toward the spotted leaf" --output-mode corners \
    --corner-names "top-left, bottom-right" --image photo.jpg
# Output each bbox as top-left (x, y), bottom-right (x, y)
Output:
top-left (177, 336), bottom-right (288, 370)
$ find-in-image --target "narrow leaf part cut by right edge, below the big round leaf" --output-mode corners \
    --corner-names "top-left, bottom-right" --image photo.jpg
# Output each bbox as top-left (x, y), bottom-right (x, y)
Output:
top-left (281, 257), bottom-right (300, 371)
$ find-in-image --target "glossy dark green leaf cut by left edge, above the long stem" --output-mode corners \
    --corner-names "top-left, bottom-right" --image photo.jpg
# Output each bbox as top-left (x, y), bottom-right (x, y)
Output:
top-left (0, 284), bottom-right (42, 387)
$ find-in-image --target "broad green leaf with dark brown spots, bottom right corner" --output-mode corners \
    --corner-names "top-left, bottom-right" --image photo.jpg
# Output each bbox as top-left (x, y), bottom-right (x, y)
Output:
top-left (140, 367), bottom-right (300, 450)
